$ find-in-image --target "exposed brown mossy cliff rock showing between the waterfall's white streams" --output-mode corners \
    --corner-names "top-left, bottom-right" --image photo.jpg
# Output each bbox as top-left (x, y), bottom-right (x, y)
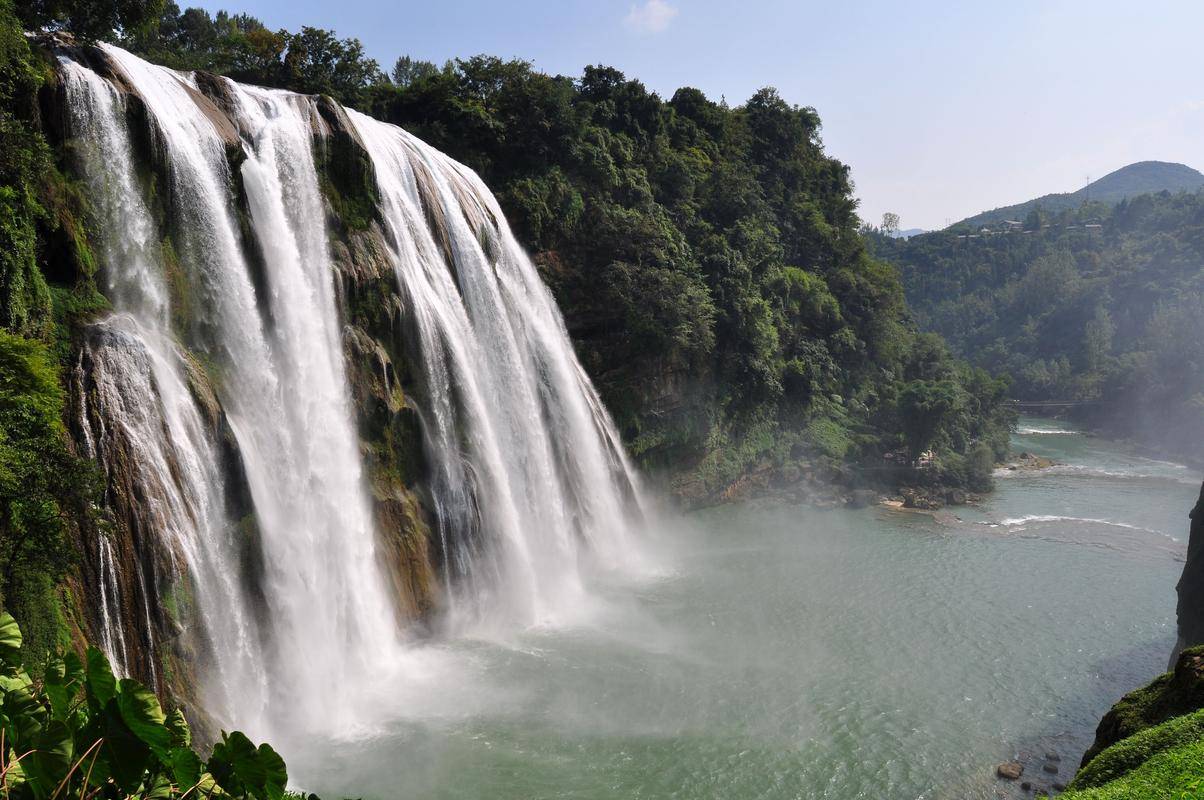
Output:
top-left (40, 45), bottom-right (441, 708)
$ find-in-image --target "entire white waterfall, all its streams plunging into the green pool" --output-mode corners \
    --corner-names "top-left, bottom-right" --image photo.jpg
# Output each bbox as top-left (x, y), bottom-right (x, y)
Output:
top-left (60, 40), bottom-right (641, 730)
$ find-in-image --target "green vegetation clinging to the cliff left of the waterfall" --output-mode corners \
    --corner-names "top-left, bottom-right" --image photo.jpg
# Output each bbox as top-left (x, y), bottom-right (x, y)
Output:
top-left (0, 0), bottom-right (118, 663)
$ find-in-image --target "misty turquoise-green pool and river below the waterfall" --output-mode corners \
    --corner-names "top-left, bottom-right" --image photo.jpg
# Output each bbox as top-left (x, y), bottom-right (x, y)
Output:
top-left (283, 420), bottom-right (1199, 800)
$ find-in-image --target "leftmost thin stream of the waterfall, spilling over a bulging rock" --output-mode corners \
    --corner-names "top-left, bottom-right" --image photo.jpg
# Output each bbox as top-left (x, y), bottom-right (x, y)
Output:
top-left (61, 60), bottom-right (265, 718)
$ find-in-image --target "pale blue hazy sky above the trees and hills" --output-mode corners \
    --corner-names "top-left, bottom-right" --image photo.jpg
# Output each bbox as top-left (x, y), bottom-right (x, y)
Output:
top-left (187, 0), bottom-right (1204, 228)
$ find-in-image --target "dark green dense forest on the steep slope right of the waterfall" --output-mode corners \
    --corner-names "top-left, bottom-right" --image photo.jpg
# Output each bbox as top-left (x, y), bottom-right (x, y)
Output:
top-left (108, 5), bottom-right (1008, 494)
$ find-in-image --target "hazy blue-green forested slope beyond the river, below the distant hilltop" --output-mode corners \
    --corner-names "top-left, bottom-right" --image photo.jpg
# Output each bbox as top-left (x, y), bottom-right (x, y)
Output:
top-left (874, 193), bottom-right (1204, 457)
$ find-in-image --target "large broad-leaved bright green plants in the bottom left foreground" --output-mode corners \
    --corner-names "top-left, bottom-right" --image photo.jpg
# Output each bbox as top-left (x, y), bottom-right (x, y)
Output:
top-left (0, 612), bottom-right (288, 800)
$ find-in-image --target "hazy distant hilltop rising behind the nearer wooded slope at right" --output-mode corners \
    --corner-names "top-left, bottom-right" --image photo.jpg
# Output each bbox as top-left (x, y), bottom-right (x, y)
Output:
top-left (957, 161), bottom-right (1204, 228)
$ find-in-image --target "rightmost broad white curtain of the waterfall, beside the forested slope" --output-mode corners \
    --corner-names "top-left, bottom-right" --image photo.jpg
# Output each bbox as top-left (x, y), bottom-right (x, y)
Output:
top-left (350, 111), bottom-right (650, 623)
